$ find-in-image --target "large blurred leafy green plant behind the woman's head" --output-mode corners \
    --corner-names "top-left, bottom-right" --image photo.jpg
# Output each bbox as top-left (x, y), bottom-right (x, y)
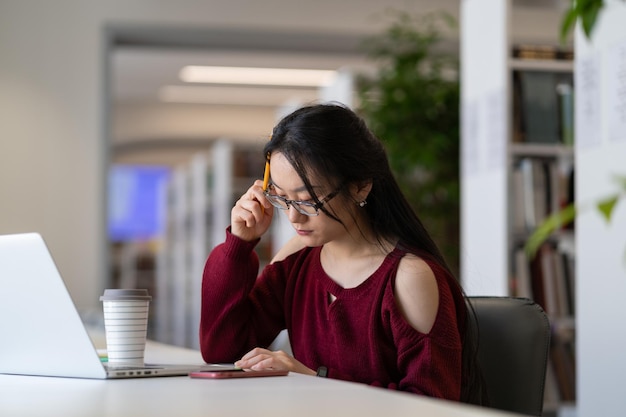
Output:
top-left (357, 11), bottom-right (460, 273)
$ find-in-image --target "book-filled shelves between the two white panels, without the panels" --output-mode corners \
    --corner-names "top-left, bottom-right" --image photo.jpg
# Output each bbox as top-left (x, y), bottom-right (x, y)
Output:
top-left (507, 52), bottom-right (576, 412)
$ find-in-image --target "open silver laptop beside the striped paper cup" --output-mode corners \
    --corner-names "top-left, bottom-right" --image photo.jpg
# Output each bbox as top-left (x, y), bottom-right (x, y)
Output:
top-left (0, 233), bottom-right (236, 379)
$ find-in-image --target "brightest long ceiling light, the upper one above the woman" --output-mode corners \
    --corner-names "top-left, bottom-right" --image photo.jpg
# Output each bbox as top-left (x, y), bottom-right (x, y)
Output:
top-left (180, 65), bottom-right (336, 87)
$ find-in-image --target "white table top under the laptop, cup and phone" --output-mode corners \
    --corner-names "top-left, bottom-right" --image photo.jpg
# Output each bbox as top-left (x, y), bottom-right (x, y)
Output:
top-left (0, 342), bottom-right (512, 417)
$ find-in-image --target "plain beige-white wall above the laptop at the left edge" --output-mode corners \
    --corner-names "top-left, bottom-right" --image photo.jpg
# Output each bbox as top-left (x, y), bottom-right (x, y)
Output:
top-left (0, 1), bottom-right (105, 307)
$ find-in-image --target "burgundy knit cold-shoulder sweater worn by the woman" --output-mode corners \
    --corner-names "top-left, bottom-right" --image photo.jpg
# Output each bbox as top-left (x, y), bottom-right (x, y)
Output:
top-left (200, 231), bottom-right (466, 400)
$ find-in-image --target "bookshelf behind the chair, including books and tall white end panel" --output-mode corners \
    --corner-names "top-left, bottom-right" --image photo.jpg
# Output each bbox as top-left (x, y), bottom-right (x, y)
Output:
top-left (461, 0), bottom-right (576, 415)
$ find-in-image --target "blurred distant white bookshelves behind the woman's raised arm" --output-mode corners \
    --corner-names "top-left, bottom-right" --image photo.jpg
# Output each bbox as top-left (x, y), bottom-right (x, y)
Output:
top-left (117, 139), bottom-right (290, 348)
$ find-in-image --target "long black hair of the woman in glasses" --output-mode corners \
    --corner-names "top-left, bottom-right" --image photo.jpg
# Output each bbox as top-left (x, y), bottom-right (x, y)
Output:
top-left (264, 104), bottom-right (485, 404)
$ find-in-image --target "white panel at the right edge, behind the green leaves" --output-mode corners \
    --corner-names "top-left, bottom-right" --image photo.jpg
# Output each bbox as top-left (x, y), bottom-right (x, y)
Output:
top-left (575, 0), bottom-right (626, 417)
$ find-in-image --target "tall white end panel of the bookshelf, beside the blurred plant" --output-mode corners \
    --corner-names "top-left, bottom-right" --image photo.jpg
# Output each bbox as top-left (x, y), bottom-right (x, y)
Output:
top-left (460, 0), bottom-right (510, 295)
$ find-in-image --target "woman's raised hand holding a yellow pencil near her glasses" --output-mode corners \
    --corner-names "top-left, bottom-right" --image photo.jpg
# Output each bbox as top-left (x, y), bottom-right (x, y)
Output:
top-left (230, 180), bottom-right (274, 242)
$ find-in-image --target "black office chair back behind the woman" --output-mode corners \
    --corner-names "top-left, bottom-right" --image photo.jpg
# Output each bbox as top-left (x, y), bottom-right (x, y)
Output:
top-left (468, 297), bottom-right (550, 416)
